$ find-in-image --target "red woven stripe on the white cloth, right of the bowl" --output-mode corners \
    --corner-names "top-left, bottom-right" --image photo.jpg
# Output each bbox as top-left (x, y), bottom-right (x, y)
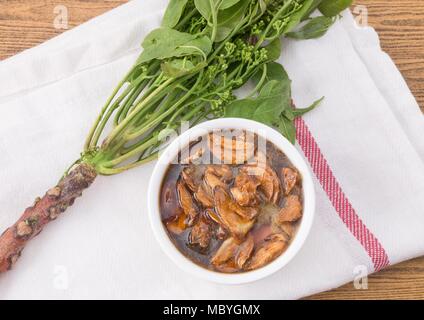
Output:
top-left (295, 118), bottom-right (389, 271)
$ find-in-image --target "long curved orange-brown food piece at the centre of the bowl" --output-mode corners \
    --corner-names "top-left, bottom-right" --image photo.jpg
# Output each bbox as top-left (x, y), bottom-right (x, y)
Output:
top-left (214, 187), bottom-right (254, 239)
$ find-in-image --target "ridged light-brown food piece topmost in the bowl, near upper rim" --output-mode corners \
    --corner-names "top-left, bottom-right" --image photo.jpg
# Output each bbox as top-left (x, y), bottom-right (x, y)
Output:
top-left (208, 131), bottom-right (255, 164)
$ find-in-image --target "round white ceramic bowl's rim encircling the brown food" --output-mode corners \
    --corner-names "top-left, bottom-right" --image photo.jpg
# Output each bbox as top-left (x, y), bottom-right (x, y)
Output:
top-left (148, 118), bottom-right (315, 284)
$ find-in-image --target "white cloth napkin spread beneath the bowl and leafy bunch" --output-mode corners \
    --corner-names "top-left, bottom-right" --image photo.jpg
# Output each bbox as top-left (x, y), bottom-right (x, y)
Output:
top-left (0, 0), bottom-right (424, 299)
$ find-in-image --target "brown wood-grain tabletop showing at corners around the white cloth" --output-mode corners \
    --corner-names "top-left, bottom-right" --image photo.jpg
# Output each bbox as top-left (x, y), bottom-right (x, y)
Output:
top-left (0, 0), bottom-right (424, 299)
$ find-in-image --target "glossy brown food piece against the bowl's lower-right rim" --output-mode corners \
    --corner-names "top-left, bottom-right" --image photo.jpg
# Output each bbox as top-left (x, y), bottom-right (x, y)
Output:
top-left (247, 233), bottom-right (287, 270)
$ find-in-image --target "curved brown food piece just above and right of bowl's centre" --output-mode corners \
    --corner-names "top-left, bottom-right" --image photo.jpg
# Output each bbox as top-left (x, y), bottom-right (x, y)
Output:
top-left (240, 164), bottom-right (280, 203)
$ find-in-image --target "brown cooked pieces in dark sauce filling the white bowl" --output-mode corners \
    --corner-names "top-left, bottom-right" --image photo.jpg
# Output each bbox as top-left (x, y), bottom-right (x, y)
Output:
top-left (159, 130), bottom-right (303, 273)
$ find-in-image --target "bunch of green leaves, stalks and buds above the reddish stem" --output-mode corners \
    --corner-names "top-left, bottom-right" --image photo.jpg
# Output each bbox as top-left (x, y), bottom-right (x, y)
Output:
top-left (80, 0), bottom-right (351, 175)
